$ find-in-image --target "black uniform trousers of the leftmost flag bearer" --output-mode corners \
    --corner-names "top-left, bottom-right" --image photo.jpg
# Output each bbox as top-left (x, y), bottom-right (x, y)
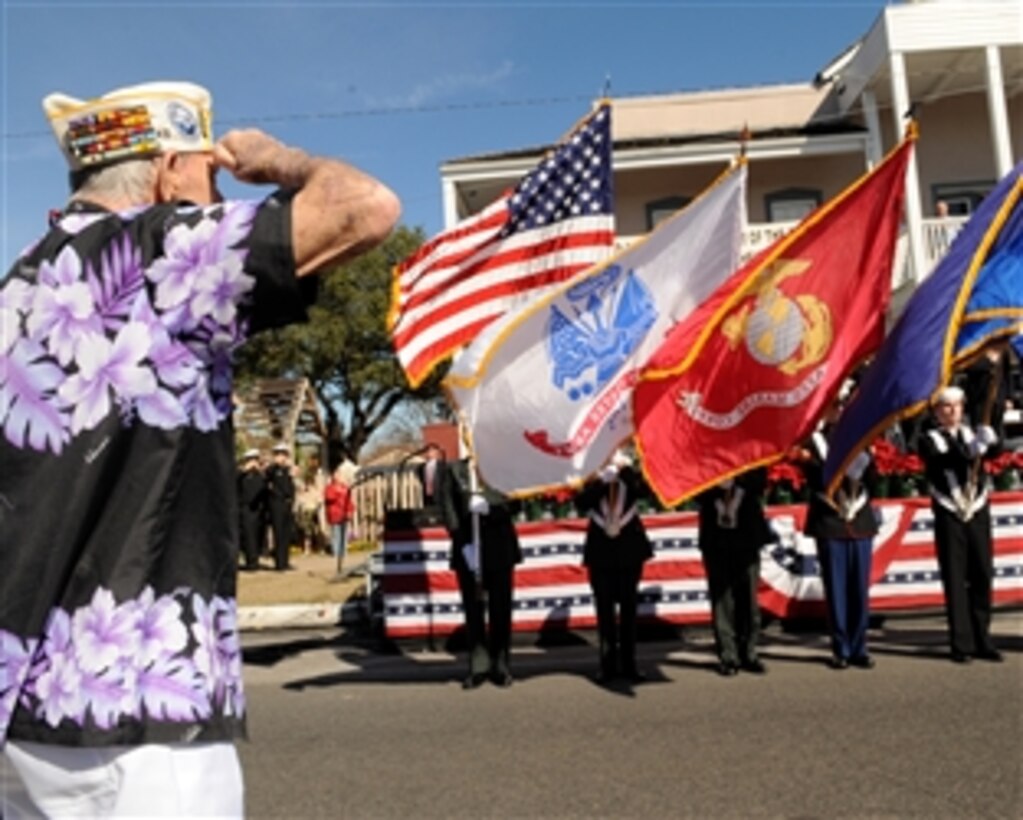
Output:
top-left (455, 558), bottom-right (514, 675)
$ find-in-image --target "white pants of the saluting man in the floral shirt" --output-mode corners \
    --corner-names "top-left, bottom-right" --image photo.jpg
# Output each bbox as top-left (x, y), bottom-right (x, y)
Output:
top-left (0, 741), bottom-right (243, 820)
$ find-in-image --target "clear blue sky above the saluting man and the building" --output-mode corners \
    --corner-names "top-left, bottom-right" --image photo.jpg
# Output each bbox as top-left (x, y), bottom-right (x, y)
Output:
top-left (0, 0), bottom-right (885, 268)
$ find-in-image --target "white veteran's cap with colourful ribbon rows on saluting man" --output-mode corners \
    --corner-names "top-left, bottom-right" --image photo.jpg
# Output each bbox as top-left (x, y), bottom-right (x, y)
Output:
top-left (43, 83), bottom-right (213, 171)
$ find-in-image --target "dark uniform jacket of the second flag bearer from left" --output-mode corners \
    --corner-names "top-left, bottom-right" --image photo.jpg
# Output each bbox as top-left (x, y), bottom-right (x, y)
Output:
top-left (575, 467), bottom-right (654, 568)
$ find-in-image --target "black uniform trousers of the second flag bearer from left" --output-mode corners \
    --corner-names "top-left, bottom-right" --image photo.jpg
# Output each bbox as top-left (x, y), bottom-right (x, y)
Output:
top-left (588, 564), bottom-right (642, 676)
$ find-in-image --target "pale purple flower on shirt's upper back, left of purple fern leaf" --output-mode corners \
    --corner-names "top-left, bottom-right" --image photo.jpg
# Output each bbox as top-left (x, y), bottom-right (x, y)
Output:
top-left (27, 245), bottom-right (103, 367)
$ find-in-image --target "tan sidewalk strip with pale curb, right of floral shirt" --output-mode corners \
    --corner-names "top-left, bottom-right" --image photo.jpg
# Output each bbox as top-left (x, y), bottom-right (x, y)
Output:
top-left (238, 551), bottom-right (372, 630)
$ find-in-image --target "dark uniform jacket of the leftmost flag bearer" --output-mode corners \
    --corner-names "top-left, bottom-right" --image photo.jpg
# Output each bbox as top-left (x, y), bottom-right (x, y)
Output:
top-left (437, 459), bottom-right (522, 573)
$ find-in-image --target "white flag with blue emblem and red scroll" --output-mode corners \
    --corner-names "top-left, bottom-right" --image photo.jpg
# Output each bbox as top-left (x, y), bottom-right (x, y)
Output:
top-left (445, 163), bottom-right (747, 496)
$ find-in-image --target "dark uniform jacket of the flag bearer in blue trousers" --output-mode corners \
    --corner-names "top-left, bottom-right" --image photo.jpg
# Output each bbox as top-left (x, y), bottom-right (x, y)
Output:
top-left (802, 429), bottom-right (878, 539)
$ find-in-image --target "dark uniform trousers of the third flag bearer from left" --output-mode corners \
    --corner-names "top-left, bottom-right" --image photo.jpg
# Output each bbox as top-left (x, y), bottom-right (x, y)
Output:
top-left (701, 544), bottom-right (760, 665)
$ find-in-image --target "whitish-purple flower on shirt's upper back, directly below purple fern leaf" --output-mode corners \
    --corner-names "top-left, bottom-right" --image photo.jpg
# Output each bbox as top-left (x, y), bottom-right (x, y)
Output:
top-left (59, 322), bottom-right (157, 434)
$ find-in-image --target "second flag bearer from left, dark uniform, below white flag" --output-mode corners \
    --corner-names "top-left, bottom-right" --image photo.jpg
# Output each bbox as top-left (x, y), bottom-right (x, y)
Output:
top-left (576, 450), bottom-right (654, 685)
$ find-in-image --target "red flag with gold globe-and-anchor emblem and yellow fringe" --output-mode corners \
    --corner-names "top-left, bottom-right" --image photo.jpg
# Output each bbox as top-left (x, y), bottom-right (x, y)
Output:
top-left (632, 135), bottom-right (914, 506)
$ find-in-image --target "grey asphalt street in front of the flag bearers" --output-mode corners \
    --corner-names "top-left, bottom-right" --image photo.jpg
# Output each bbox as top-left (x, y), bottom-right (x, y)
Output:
top-left (240, 612), bottom-right (1023, 818)
